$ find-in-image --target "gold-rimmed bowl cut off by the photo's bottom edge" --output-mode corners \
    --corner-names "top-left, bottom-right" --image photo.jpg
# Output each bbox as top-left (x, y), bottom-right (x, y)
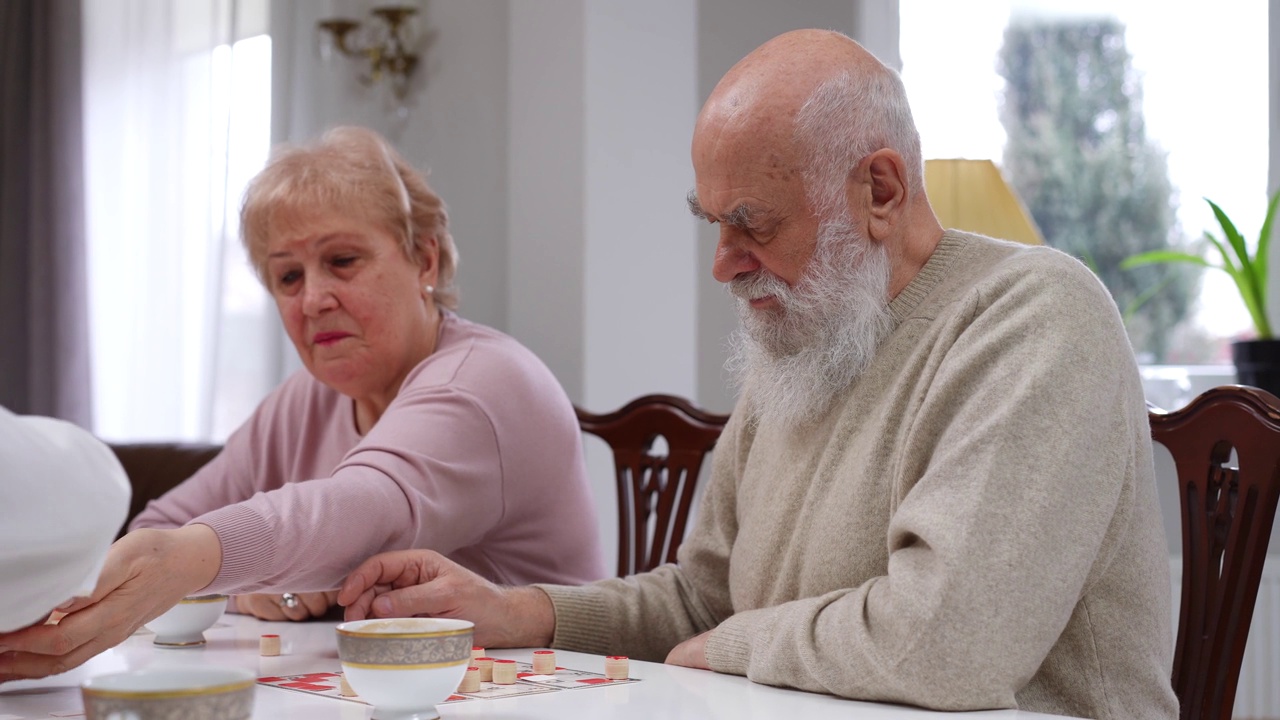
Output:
top-left (81, 666), bottom-right (257, 720)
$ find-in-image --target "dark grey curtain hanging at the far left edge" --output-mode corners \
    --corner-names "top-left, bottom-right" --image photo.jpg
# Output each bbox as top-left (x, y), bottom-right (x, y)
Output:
top-left (0, 0), bottom-right (92, 428)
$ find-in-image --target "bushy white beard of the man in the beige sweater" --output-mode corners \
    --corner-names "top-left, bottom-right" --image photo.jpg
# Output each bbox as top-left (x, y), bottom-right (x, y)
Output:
top-left (726, 219), bottom-right (891, 425)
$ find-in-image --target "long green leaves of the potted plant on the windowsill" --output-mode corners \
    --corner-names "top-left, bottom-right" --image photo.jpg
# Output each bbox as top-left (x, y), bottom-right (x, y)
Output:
top-left (1120, 190), bottom-right (1280, 340)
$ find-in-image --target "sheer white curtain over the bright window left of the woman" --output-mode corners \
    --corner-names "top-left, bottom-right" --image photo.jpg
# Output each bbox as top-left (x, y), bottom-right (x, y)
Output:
top-left (83, 0), bottom-right (279, 439)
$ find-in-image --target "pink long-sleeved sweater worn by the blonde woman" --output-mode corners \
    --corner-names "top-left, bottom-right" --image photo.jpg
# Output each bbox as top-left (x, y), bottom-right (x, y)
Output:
top-left (129, 313), bottom-right (607, 593)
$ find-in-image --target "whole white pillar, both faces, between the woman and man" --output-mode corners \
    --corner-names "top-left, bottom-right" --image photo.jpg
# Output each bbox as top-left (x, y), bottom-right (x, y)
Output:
top-left (508, 0), bottom-right (696, 566)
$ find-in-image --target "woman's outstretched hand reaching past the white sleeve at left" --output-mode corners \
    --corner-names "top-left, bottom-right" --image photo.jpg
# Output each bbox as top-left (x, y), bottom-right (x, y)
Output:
top-left (0, 524), bottom-right (223, 682)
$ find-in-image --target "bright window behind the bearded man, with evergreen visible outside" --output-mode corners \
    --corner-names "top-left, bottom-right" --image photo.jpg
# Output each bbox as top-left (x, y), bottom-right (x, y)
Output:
top-left (900, 0), bottom-right (1268, 384)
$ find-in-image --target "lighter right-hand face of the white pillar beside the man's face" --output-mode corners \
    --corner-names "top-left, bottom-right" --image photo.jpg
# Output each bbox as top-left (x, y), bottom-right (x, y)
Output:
top-left (582, 0), bottom-right (700, 410)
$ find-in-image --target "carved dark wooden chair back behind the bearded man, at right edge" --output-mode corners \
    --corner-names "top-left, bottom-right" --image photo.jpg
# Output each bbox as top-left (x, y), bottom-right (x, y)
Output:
top-left (1148, 386), bottom-right (1280, 720)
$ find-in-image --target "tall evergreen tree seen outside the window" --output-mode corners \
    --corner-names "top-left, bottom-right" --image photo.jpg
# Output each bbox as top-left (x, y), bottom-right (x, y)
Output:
top-left (997, 19), bottom-right (1199, 361)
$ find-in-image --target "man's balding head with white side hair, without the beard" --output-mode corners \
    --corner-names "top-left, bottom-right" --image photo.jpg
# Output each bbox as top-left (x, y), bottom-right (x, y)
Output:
top-left (690, 29), bottom-right (942, 292)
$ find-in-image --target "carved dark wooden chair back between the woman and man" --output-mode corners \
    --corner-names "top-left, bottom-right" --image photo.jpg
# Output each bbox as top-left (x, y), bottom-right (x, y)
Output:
top-left (575, 395), bottom-right (728, 578)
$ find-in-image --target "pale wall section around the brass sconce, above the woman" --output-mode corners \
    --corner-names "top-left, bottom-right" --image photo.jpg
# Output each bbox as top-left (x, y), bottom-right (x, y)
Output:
top-left (271, 0), bottom-right (509, 328)
